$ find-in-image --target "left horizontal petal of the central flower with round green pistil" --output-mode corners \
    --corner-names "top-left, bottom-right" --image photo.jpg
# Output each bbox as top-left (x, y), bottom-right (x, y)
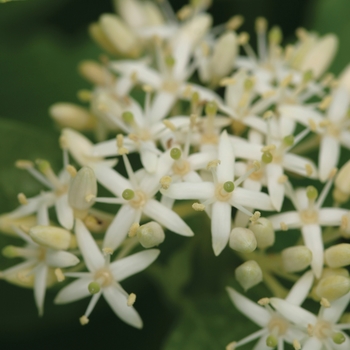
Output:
top-left (160, 182), bottom-right (215, 200)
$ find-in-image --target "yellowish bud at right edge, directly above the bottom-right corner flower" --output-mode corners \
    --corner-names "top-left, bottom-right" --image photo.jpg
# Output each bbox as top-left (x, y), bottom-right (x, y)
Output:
top-left (315, 276), bottom-right (350, 301)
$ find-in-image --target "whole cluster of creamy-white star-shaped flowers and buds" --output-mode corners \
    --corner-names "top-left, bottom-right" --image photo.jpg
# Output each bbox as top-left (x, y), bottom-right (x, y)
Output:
top-left (0, 0), bottom-right (350, 350)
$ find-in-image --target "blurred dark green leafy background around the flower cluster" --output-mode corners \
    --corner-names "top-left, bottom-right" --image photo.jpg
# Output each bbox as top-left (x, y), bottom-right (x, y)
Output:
top-left (0, 0), bottom-right (350, 350)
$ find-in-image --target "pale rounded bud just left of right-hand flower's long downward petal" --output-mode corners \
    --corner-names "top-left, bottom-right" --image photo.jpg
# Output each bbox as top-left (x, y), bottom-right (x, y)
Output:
top-left (282, 246), bottom-right (312, 272)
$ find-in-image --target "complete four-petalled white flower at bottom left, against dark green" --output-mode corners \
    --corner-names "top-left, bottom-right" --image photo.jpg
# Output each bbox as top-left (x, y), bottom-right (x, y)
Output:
top-left (55, 219), bottom-right (159, 328)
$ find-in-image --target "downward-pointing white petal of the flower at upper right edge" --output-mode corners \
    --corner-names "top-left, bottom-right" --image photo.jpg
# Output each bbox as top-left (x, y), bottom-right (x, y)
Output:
top-left (318, 135), bottom-right (340, 182)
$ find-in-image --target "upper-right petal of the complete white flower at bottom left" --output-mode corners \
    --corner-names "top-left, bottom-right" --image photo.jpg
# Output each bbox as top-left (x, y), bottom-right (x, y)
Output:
top-left (110, 249), bottom-right (160, 282)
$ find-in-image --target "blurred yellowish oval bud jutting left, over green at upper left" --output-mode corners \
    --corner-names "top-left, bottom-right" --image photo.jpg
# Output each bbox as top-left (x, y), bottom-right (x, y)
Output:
top-left (49, 102), bottom-right (96, 131)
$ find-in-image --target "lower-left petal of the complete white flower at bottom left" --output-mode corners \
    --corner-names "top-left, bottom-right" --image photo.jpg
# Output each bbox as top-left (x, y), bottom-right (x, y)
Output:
top-left (55, 276), bottom-right (93, 304)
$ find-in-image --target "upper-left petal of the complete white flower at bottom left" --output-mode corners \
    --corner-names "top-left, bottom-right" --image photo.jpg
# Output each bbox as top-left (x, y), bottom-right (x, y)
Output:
top-left (75, 219), bottom-right (104, 271)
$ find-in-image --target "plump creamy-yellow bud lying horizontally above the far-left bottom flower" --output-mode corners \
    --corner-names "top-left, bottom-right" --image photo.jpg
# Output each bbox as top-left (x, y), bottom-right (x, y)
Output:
top-left (29, 225), bottom-right (72, 250)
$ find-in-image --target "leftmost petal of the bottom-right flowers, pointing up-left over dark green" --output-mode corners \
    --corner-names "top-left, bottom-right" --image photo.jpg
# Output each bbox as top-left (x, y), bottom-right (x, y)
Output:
top-left (226, 287), bottom-right (271, 327)
